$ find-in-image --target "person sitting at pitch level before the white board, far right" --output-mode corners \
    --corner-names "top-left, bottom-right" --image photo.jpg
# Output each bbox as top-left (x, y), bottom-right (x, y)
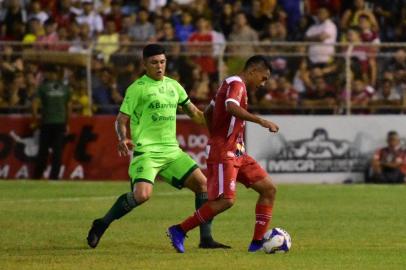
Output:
top-left (365, 131), bottom-right (406, 184)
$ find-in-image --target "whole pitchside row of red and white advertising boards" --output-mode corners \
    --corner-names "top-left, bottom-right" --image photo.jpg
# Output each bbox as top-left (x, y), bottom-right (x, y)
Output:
top-left (0, 115), bottom-right (406, 183)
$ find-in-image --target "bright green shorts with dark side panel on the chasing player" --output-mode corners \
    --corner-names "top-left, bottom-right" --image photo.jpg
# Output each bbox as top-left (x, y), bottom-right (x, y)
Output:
top-left (128, 148), bottom-right (198, 190)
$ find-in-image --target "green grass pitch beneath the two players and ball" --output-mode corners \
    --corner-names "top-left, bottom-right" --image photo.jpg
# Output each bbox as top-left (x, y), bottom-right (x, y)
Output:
top-left (0, 181), bottom-right (406, 270)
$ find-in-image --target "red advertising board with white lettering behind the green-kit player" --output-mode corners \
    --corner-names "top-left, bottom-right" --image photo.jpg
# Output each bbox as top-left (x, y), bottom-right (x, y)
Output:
top-left (0, 115), bottom-right (207, 180)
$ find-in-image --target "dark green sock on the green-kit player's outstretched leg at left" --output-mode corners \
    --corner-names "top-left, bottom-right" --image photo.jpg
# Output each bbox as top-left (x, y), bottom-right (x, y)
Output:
top-left (102, 192), bottom-right (138, 224)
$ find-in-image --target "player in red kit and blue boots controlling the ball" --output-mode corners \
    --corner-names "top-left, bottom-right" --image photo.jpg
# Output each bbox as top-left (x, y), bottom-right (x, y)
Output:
top-left (167, 55), bottom-right (279, 253)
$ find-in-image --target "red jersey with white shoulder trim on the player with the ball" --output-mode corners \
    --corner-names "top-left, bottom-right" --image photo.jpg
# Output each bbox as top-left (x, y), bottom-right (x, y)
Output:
top-left (208, 76), bottom-right (248, 162)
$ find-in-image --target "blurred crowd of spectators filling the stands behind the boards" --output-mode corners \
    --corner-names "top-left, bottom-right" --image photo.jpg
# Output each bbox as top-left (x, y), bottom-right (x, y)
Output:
top-left (0, 0), bottom-right (406, 115)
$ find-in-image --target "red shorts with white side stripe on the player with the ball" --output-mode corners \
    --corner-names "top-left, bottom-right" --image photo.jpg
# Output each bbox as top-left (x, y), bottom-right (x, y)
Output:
top-left (207, 155), bottom-right (268, 200)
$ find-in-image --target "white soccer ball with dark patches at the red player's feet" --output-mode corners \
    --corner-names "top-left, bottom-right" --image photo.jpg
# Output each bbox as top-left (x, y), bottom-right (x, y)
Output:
top-left (262, 228), bottom-right (292, 254)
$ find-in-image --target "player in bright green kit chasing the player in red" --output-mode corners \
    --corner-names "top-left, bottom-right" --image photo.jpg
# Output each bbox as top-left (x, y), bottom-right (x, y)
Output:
top-left (87, 44), bottom-right (230, 248)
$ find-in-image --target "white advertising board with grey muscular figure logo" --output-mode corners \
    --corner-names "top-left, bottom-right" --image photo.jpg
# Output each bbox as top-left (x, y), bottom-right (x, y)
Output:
top-left (245, 115), bottom-right (406, 183)
